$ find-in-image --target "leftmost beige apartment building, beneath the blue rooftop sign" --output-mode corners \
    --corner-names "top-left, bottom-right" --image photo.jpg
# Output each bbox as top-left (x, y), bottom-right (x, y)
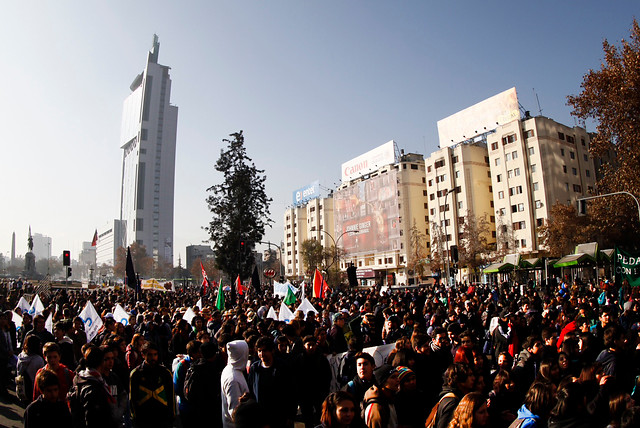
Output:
top-left (282, 196), bottom-right (335, 280)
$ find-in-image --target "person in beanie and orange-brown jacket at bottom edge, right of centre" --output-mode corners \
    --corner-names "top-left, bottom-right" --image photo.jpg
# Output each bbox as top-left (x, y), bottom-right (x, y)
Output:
top-left (363, 364), bottom-right (400, 428)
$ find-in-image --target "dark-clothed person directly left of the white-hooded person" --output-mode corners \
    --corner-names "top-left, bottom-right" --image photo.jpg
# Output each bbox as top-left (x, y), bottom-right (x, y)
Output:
top-left (182, 342), bottom-right (225, 428)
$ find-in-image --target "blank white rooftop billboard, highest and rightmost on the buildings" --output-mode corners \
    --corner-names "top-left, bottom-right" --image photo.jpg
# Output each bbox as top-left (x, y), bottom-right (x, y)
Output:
top-left (438, 87), bottom-right (520, 147)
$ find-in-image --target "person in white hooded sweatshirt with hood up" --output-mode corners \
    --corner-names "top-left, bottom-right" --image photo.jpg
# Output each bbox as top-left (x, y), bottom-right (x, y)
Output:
top-left (220, 340), bottom-right (249, 428)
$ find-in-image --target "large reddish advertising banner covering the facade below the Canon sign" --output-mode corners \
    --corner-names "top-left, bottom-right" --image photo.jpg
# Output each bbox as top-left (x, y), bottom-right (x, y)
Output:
top-left (333, 170), bottom-right (401, 255)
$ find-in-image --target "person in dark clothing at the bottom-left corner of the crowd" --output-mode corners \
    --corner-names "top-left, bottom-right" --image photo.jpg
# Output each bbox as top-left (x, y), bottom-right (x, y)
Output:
top-left (24, 370), bottom-right (72, 428)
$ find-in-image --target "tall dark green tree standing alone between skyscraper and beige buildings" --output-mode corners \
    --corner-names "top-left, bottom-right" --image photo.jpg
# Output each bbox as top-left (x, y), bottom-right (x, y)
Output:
top-left (205, 131), bottom-right (273, 278)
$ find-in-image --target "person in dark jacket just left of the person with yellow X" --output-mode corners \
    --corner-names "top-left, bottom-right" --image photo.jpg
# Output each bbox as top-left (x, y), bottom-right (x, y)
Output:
top-left (67, 346), bottom-right (119, 428)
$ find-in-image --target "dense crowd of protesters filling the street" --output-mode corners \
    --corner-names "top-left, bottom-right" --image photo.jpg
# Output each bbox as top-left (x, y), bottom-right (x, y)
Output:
top-left (0, 278), bottom-right (640, 428)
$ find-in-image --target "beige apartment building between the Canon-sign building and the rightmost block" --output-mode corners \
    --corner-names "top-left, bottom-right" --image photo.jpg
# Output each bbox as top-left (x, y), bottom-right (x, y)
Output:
top-left (425, 140), bottom-right (496, 275)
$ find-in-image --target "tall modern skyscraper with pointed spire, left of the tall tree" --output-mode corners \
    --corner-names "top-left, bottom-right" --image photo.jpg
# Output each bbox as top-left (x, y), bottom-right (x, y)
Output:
top-left (120, 35), bottom-right (178, 263)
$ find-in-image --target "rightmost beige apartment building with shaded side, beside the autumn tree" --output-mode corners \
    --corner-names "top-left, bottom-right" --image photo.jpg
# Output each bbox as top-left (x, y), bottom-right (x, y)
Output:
top-left (487, 116), bottom-right (596, 256)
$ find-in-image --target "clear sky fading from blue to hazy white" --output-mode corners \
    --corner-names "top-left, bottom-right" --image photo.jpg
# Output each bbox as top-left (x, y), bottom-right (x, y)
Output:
top-left (0, 0), bottom-right (640, 261)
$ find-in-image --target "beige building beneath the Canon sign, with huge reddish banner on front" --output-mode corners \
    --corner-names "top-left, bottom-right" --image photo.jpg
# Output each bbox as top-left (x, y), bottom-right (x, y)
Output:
top-left (334, 146), bottom-right (430, 286)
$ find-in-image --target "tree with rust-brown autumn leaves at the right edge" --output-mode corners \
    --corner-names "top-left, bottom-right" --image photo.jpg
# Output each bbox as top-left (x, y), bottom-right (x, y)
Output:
top-left (541, 19), bottom-right (640, 256)
